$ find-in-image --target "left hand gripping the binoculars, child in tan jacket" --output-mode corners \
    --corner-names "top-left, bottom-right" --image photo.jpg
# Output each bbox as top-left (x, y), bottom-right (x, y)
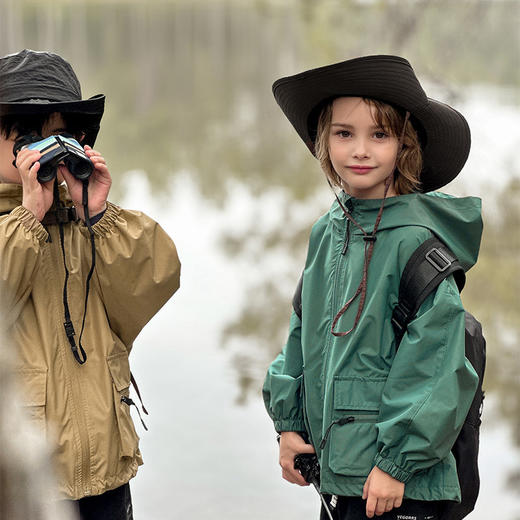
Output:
top-left (16, 148), bottom-right (54, 222)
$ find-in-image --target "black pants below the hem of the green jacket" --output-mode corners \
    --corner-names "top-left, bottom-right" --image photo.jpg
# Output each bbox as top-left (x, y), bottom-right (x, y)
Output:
top-left (320, 495), bottom-right (445, 520)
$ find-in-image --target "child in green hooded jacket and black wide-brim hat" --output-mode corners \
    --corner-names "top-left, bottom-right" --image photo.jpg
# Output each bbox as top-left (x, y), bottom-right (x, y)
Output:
top-left (263, 56), bottom-right (482, 520)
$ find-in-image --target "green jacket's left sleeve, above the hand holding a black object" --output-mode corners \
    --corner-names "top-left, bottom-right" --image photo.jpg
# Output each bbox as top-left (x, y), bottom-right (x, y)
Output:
top-left (262, 312), bottom-right (306, 432)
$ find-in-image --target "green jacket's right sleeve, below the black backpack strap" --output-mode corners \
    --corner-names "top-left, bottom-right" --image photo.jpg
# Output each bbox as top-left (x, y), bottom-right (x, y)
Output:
top-left (375, 276), bottom-right (478, 483)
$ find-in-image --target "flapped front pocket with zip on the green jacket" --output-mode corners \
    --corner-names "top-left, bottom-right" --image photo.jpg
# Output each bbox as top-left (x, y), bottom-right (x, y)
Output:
top-left (324, 377), bottom-right (385, 477)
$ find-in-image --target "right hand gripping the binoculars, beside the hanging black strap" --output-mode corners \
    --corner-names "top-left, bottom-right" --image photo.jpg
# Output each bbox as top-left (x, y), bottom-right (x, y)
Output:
top-left (59, 145), bottom-right (112, 220)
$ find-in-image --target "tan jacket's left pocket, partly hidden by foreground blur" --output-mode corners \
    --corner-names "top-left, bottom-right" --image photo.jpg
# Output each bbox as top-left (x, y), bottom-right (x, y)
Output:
top-left (16, 368), bottom-right (47, 433)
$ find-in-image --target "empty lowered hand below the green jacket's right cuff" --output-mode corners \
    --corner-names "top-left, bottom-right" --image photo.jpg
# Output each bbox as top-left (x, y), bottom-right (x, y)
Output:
top-left (363, 466), bottom-right (404, 518)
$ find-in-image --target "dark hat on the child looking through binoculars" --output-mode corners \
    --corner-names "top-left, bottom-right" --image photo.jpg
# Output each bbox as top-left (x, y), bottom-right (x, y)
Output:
top-left (0, 49), bottom-right (105, 146)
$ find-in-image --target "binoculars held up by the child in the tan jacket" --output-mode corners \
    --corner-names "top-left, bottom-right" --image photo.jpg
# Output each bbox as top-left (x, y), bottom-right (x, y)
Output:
top-left (13, 135), bottom-right (94, 183)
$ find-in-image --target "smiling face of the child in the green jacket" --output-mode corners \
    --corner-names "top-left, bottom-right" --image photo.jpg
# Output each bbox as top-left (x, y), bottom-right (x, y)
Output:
top-left (329, 97), bottom-right (398, 199)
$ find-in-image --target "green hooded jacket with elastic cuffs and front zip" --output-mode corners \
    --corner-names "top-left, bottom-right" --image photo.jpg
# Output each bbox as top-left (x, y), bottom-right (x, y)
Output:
top-left (263, 193), bottom-right (482, 501)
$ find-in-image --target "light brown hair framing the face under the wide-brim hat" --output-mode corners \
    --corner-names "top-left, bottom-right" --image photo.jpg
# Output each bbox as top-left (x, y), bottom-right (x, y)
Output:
top-left (314, 98), bottom-right (422, 195)
